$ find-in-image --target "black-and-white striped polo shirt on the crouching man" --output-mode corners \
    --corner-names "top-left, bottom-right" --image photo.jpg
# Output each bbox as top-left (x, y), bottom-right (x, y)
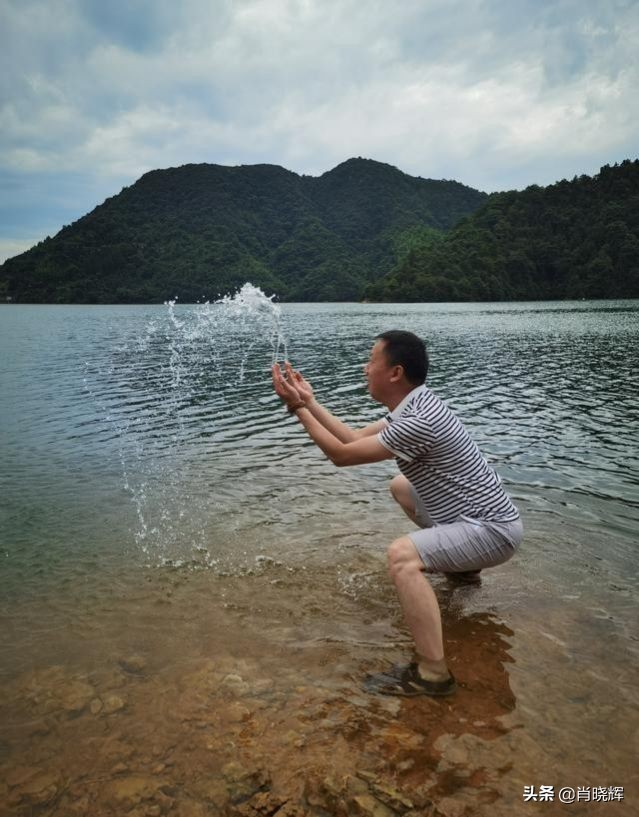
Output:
top-left (378, 386), bottom-right (519, 524)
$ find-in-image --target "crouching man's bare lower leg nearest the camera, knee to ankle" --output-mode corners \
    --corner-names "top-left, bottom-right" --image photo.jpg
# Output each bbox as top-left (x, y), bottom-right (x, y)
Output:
top-left (388, 536), bottom-right (450, 681)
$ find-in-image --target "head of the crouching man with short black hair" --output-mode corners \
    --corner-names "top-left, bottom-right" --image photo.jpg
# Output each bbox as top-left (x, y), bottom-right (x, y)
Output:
top-left (366, 329), bottom-right (428, 403)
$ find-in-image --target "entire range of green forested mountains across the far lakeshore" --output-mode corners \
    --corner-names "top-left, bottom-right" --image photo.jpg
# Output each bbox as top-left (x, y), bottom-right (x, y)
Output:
top-left (0, 159), bottom-right (639, 303)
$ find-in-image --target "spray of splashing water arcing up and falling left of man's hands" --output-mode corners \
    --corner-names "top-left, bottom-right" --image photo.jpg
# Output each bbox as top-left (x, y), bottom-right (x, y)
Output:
top-left (85, 283), bottom-right (287, 566)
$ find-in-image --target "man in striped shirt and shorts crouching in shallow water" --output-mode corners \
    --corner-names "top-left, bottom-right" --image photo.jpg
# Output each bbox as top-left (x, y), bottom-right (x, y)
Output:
top-left (273, 330), bottom-right (523, 696)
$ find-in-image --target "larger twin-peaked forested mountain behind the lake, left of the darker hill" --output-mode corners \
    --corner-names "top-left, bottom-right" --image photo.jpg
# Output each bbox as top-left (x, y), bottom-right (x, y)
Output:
top-left (0, 159), bottom-right (487, 303)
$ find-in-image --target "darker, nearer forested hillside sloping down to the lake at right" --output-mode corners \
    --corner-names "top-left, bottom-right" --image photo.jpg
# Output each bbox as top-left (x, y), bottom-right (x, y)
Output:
top-left (365, 160), bottom-right (639, 301)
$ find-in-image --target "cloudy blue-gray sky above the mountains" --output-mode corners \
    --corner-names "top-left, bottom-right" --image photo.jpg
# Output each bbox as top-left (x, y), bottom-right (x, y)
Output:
top-left (0, 0), bottom-right (639, 261)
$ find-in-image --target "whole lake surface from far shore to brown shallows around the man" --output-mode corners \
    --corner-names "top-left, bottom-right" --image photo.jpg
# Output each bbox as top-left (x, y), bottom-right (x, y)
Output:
top-left (0, 301), bottom-right (639, 817)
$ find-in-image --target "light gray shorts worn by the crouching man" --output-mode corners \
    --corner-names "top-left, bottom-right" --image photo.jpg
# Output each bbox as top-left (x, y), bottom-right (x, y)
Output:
top-left (408, 485), bottom-right (524, 573)
